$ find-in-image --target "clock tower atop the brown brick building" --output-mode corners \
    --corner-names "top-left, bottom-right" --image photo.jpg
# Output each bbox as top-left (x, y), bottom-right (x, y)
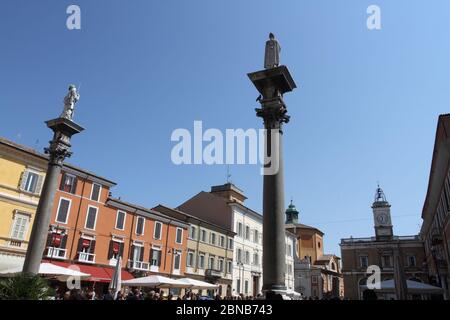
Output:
top-left (372, 186), bottom-right (393, 240)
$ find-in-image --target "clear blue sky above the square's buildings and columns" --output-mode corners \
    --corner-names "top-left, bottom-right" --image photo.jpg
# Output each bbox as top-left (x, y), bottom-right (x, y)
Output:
top-left (0, 0), bottom-right (450, 253)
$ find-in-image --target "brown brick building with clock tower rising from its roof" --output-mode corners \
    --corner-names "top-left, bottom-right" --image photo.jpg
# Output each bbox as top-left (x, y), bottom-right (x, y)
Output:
top-left (340, 187), bottom-right (428, 300)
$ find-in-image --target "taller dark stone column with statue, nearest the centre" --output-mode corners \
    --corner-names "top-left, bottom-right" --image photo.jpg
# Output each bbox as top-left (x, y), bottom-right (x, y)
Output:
top-left (248, 34), bottom-right (296, 298)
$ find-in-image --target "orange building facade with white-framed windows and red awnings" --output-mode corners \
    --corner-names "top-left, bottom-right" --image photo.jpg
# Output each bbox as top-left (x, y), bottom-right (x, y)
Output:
top-left (43, 166), bottom-right (188, 283)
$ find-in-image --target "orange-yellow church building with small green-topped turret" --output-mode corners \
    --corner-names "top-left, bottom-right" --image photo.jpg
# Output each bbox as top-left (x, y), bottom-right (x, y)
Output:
top-left (286, 201), bottom-right (344, 299)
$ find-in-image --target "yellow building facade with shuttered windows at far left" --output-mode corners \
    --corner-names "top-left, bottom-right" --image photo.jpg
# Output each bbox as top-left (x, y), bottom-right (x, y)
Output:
top-left (0, 138), bottom-right (47, 270)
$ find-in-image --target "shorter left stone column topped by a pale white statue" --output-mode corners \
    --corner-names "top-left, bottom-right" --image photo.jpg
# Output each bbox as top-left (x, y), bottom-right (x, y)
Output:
top-left (23, 86), bottom-right (84, 274)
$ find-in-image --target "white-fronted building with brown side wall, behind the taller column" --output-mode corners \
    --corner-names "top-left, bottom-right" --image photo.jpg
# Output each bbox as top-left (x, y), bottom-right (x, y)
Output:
top-left (177, 183), bottom-right (294, 296)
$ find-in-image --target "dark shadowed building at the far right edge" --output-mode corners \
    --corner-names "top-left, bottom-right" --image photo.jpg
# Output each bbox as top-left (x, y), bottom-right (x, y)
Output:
top-left (420, 114), bottom-right (450, 299)
